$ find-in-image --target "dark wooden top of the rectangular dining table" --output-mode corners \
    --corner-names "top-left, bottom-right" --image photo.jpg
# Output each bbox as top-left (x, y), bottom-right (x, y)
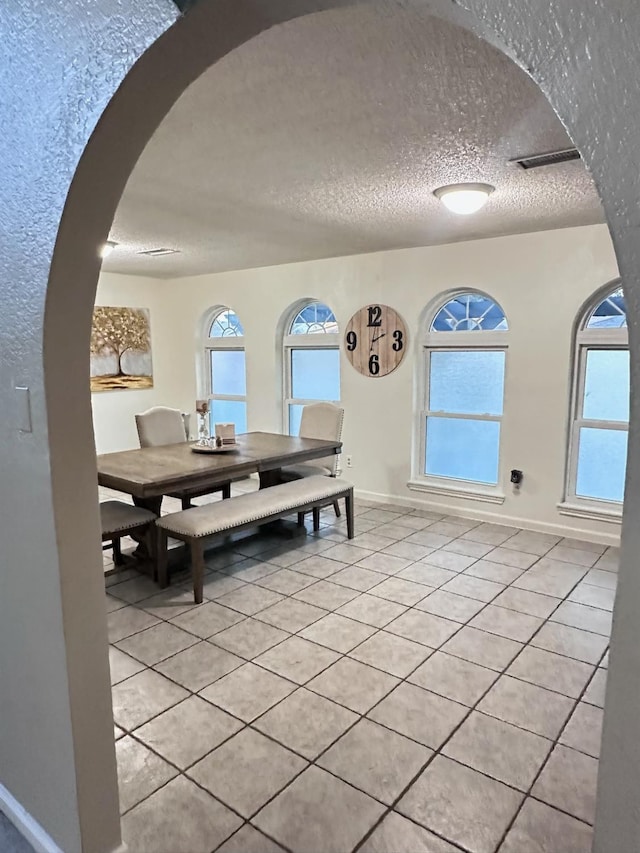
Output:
top-left (97, 432), bottom-right (342, 502)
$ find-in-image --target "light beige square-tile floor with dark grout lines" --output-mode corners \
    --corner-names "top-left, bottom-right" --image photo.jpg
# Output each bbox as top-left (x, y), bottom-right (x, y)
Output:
top-left (104, 482), bottom-right (618, 853)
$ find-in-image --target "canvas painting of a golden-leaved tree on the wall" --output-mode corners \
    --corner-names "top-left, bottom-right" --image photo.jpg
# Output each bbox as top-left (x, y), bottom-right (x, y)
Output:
top-left (91, 306), bottom-right (153, 391)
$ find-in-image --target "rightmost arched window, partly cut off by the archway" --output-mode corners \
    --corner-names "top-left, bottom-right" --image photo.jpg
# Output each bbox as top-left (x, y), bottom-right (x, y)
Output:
top-left (567, 286), bottom-right (629, 506)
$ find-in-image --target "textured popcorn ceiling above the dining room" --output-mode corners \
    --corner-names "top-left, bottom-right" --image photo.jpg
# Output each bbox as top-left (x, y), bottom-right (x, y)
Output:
top-left (103, 2), bottom-right (603, 277)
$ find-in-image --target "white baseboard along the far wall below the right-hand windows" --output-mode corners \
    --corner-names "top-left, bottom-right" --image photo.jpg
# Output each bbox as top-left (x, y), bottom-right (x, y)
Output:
top-left (355, 489), bottom-right (620, 545)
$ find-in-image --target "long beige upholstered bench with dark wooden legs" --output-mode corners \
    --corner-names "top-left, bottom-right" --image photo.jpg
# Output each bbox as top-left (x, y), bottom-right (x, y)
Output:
top-left (156, 475), bottom-right (353, 604)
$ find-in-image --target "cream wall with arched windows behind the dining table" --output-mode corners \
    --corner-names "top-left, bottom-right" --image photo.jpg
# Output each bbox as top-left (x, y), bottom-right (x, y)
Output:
top-left (94, 226), bottom-right (619, 539)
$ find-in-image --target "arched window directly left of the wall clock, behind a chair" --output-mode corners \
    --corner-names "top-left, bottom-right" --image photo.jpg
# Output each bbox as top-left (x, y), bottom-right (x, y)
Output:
top-left (283, 302), bottom-right (340, 435)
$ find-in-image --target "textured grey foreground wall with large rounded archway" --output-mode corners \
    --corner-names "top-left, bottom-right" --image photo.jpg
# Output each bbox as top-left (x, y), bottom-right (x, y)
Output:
top-left (0, 0), bottom-right (640, 851)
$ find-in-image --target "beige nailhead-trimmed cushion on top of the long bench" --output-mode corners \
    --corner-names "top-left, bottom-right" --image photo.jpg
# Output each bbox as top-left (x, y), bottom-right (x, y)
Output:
top-left (156, 475), bottom-right (353, 539)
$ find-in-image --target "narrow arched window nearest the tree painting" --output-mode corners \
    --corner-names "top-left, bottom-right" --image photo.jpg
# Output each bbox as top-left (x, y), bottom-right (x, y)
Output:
top-left (204, 308), bottom-right (247, 434)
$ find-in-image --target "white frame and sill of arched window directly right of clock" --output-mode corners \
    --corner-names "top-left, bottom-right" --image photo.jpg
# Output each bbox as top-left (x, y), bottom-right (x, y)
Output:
top-left (407, 288), bottom-right (509, 504)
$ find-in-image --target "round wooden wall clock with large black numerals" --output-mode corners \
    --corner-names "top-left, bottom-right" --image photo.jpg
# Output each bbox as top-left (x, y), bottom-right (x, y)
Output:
top-left (344, 305), bottom-right (407, 378)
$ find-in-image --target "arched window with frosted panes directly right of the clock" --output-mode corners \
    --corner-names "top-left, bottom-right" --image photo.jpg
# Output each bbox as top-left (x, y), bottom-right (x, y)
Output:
top-left (415, 292), bottom-right (508, 487)
